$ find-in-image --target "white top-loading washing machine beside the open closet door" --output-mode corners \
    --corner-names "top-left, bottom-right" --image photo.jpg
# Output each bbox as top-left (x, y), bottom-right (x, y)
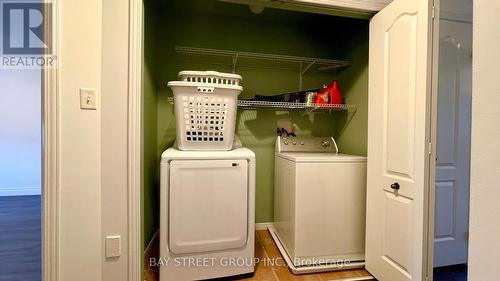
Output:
top-left (270, 137), bottom-right (366, 274)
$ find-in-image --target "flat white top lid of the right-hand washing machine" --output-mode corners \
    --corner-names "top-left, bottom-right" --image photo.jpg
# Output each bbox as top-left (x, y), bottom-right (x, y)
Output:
top-left (276, 152), bottom-right (366, 163)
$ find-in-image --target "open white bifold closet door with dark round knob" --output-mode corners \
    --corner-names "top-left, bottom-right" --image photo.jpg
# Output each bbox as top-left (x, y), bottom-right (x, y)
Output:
top-left (366, 0), bottom-right (432, 281)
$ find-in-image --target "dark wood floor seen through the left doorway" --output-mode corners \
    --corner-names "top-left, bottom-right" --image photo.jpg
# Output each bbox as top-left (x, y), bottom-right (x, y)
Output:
top-left (0, 196), bottom-right (42, 281)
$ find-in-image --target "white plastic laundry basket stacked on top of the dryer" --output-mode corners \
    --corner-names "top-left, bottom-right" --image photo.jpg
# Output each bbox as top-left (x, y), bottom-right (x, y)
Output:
top-left (168, 71), bottom-right (243, 150)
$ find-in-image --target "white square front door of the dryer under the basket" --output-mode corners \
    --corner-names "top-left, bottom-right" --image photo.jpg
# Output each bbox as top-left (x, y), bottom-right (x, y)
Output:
top-left (169, 160), bottom-right (248, 254)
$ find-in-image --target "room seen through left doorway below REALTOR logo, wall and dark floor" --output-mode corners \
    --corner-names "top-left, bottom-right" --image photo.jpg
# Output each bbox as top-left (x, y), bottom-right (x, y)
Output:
top-left (0, 69), bottom-right (42, 281)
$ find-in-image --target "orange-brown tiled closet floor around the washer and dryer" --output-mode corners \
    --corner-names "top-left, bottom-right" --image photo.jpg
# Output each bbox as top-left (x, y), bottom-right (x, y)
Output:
top-left (145, 230), bottom-right (370, 281)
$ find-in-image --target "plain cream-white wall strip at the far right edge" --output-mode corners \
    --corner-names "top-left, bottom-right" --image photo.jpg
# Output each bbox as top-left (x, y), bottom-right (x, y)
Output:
top-left (469, 0), bottom-right (500, 281)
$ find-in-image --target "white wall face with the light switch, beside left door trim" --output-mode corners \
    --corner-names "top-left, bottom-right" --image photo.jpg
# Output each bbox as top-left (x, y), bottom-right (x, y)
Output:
top-left (57, 0), bottom-right (103, 281)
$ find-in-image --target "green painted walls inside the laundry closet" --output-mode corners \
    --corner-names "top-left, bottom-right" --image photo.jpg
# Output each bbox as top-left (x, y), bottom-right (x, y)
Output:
top-left (144, 0), bottom-right (368, 246)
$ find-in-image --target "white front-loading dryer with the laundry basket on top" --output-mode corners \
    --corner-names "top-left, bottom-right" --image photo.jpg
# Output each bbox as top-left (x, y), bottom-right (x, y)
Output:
top-left (160, 143), bottom-right (255, 281)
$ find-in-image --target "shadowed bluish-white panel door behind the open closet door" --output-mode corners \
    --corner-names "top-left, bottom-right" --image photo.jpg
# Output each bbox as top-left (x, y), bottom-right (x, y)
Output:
top-left (434, 19), bottom-right (472, 266)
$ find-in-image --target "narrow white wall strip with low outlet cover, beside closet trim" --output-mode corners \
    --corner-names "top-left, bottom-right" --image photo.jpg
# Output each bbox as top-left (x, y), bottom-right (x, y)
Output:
top-left (101, 0), bottom-right (129, 280)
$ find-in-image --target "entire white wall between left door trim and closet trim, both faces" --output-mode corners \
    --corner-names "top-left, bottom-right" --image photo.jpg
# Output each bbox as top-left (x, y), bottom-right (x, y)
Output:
top-left (59, 0), bottom-right (133, 281)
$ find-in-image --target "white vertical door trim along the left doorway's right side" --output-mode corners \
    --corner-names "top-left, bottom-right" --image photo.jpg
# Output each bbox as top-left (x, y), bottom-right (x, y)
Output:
top-left (40, 1), bottom-right (61, 281)
